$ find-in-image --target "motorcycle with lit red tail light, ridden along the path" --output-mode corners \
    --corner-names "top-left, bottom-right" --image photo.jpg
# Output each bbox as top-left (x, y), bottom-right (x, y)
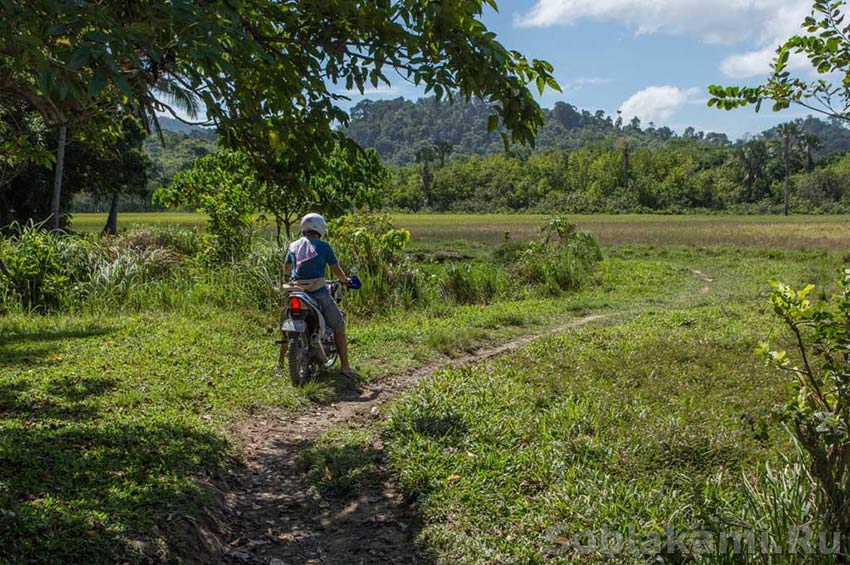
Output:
top-left (279, 275), bottom-right (360, 386)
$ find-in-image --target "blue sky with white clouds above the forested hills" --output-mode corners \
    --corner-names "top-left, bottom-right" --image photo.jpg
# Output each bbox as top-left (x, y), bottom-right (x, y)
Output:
top-left (342, 0), bottom-right (811, 138)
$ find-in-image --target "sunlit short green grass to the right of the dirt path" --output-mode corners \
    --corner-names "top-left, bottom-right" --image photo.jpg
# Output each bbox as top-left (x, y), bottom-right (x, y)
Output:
top-left (385, 247), bottom-right (840, 563)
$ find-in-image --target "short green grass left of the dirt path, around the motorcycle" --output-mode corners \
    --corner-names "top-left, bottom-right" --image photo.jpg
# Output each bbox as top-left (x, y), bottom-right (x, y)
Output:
top-left (0, 247), bottom-right (648, 563)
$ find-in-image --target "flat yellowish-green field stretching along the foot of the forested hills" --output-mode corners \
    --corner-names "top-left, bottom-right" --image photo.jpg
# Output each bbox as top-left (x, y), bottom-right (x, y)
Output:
top-left (73, 212), bottom-right (850, 251)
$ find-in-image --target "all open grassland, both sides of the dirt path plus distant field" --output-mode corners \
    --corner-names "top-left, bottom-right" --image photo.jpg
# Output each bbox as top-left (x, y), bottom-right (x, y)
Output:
top-left (0, 214), bottom-right (850, 563)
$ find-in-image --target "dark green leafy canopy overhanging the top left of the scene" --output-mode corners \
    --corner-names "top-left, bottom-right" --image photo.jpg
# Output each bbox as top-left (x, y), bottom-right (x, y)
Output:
top-left (0, 0), bottom-right (558, 227)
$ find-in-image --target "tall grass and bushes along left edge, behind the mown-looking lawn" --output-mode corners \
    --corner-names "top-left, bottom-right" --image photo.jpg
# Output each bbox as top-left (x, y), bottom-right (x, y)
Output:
top-left (0, 224), bottom-right (214, 313)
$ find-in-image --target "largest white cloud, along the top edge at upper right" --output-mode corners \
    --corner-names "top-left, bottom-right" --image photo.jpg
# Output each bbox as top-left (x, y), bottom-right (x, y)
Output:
top-left (516, 0), bottom-right (812, 78)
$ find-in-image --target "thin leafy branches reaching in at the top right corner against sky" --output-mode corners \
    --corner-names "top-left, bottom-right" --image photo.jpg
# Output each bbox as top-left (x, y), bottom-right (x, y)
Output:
top-left (708, 0), bottom-right (850, 121)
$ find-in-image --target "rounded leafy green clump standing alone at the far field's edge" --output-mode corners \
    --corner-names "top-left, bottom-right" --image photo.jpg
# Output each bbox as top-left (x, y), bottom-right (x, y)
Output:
top-left (510, 218), bottom-right (602, 295)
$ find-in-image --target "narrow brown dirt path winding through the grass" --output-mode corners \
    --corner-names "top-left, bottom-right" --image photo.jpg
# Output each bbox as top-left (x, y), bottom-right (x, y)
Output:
top-left (210, 316), bottom-right (603, 565)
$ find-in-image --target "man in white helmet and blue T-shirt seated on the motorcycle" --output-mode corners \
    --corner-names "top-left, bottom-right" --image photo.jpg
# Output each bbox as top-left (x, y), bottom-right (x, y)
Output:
top-left (283, 214), bottom-right (357, 377)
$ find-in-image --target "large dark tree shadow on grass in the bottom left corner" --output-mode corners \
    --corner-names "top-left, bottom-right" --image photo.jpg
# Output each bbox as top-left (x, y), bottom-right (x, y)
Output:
top-left (0, 377), bottom-right (232, 563)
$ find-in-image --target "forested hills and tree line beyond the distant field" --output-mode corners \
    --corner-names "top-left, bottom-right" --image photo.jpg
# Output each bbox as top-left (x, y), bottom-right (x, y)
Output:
top-left (69, 98), bottom-right (850, 213)
